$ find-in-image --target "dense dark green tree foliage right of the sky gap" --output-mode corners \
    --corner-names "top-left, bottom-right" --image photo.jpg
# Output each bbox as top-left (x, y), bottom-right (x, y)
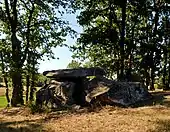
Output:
top-left (71, 0), bottom-right (170, 89)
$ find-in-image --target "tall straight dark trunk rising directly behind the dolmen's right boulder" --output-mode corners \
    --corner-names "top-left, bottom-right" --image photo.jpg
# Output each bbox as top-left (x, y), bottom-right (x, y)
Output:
top-left (120, 0), bottom-right (127, 79)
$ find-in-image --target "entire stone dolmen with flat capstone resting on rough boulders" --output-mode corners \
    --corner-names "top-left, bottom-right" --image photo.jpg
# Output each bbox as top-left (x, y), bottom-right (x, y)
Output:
top-left (36, 68), bottom-right (152, 107)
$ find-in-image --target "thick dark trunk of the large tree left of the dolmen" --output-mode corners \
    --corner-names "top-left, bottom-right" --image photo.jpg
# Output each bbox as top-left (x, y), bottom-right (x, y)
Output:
top-left (4, 0), bottom-right (24, 106)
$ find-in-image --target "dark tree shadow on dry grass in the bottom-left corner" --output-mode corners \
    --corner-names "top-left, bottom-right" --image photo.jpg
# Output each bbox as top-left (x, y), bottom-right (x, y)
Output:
top-left (0, 120), bottom-right (43, 132)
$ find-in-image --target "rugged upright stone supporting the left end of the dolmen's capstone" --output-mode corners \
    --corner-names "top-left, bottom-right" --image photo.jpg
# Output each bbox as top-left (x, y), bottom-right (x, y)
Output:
top-left (36, 80), bottom-right (75, 108)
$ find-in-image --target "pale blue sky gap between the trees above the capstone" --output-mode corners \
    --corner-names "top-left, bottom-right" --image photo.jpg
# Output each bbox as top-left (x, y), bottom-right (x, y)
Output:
top-left (38, 13), bottom-right (82, 73)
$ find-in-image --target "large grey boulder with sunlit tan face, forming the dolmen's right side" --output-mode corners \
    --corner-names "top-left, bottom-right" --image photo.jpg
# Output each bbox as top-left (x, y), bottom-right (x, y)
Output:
top-left (86, 77), bottom-right (152, 106)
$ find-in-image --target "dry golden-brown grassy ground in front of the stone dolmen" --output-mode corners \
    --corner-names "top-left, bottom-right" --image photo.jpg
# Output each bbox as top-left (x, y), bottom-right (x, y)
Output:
top-left (0, 92), bottom-right (170, 132)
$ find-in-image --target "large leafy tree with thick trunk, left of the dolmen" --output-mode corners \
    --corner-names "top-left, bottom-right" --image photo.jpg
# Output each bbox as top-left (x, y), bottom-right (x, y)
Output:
top-left (0, 0), bottom-right (73, 106)
